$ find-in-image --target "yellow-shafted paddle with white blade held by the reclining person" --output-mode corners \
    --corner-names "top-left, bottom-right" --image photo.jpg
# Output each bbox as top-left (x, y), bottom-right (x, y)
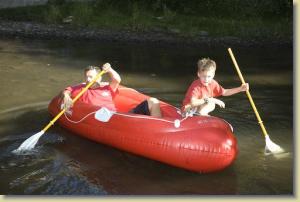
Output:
top-left (13, 70), bottom-right (105, 153)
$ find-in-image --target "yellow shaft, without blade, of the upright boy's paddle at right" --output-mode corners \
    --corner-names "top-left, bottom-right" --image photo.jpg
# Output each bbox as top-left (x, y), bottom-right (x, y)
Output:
top-left (228, 48), bottom-right (268, 136)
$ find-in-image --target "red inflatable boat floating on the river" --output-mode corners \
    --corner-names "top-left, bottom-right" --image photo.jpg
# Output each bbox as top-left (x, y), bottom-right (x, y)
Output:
top-left (49, 87), bottom-right (238, 172)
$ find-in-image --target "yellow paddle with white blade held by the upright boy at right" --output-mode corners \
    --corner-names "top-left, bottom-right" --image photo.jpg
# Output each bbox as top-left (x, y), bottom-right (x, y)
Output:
top-left (228, 48), bottom-right (284, 153)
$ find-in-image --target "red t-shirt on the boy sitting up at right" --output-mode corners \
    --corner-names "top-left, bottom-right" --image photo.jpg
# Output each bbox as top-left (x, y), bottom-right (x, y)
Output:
top-left (182, 79), bottom-right (224, 108)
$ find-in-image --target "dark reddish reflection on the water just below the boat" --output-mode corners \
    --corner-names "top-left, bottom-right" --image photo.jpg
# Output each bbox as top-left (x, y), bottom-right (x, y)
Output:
top-left (58, 129), bottom-right (236, 195)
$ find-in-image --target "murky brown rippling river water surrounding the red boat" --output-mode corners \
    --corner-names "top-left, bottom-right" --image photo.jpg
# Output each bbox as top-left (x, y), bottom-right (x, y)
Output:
top-left (0, 39), bottom-right (294, 195)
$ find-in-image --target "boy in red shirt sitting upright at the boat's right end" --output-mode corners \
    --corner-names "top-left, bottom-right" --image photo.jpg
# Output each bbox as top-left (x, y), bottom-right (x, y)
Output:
top-left (182, 58), bottom-right (249, 116)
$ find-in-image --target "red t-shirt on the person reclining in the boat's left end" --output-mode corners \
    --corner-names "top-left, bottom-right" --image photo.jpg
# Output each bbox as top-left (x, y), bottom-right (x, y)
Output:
top-left (65, 83), bottom-right (116, 111)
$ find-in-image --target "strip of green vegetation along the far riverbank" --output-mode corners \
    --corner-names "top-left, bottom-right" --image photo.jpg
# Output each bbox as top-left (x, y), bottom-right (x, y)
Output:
top-left (0, 0), bottom-right (293, 40)
